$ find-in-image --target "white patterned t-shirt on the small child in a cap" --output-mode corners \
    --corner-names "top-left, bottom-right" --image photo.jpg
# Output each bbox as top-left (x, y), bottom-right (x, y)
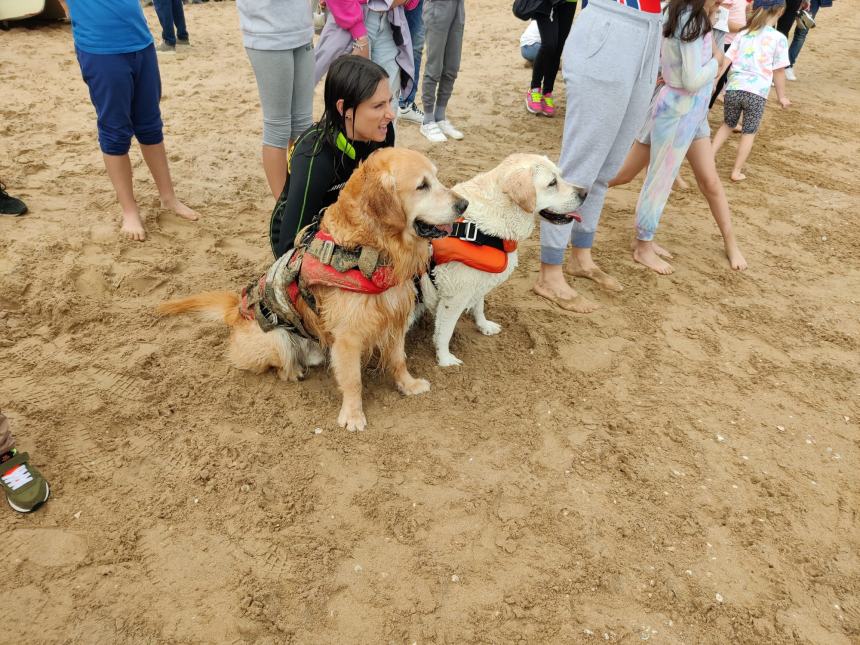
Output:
top-left (726, 27), bottom-right (789, 98)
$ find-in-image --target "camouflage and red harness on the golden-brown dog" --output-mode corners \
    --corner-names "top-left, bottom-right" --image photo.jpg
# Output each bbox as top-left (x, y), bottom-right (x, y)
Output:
top-left (239, 228), bottom-right (394, 338)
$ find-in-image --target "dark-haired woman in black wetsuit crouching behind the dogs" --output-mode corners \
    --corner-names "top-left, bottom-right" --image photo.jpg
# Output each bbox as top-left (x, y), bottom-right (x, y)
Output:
top-left (269, 56), bottom-right (394, 257)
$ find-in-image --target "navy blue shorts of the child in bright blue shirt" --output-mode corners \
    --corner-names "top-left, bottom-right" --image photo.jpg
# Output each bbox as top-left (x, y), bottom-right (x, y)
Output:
top-left (75, 45), bottom-right (164, 155)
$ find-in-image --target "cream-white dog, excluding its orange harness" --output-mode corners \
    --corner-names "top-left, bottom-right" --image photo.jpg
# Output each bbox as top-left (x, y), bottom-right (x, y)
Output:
top-left (415, 154), bottom-right (587, 367)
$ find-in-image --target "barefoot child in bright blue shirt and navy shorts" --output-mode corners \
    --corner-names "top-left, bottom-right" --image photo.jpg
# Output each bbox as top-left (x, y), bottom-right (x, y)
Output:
top-left (68, 0), bottom-right (198, 241)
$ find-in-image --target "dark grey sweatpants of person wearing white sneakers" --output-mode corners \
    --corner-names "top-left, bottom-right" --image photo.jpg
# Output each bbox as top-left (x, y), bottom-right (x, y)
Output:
top-left (421, 0), bottom-right (466, 123)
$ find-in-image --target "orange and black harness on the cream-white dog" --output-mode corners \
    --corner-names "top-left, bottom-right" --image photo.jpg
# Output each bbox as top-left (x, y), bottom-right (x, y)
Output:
top-left (433, 219), bottom-right (517, 273)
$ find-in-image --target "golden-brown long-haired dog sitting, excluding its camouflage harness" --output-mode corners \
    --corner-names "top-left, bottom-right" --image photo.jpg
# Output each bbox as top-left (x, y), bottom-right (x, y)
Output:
top-left (158, 148), bottom-right (468, 431)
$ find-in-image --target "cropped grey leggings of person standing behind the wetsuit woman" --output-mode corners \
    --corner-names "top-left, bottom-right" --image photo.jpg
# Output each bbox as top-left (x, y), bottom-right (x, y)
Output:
top-left (245, 43), bottom-right (314, 148)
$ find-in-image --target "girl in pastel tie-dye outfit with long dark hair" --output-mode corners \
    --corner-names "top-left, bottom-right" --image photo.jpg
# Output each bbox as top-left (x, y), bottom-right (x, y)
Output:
top-left (633, 0), bottom-right (722, 275)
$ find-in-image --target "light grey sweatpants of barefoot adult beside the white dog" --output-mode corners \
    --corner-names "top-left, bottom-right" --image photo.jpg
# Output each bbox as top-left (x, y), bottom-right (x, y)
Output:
top-left (541, 0), bottom-right (661, 264)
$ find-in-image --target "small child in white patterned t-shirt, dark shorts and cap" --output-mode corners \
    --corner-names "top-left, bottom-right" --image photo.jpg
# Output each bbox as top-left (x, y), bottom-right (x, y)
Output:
top-left (714, 0), bottom-right (791, 181)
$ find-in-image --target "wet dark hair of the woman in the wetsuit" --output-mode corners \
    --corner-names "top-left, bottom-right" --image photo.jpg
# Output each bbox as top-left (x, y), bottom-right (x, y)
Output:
top-left (318, 55), bottom-right (388, 146)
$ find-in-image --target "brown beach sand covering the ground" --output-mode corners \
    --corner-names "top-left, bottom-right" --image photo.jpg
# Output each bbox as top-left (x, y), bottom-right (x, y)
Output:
top-left (0, 0), bottom-right (860, 645)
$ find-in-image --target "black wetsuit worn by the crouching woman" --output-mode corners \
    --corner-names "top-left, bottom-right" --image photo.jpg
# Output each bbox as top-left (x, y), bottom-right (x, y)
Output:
top-left (269, 124), bottom-right (394, 257)
